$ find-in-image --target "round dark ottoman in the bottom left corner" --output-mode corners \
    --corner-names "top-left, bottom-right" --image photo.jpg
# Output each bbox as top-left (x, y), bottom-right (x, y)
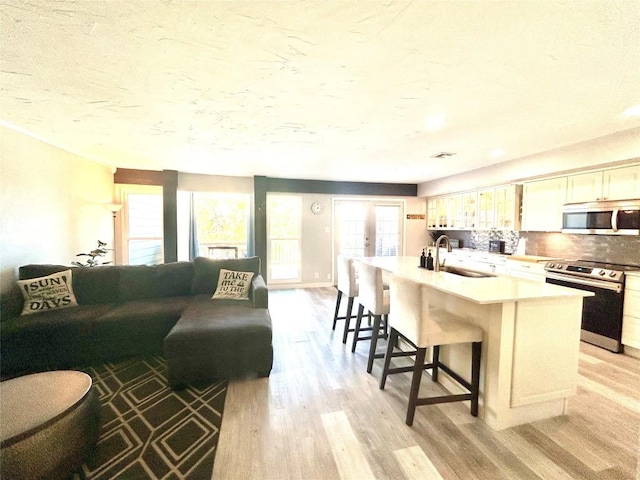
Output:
top-left (0, 371), bottom-right (100, 480)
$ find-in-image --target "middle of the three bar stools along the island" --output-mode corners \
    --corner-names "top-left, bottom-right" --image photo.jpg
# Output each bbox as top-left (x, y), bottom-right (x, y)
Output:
top-left (351, 262), bottom-right (389, 373)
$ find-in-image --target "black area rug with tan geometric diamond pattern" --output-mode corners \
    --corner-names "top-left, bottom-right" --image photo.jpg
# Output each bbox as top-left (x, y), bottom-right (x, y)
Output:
top-left (74, 356), bottom-right (227, 480)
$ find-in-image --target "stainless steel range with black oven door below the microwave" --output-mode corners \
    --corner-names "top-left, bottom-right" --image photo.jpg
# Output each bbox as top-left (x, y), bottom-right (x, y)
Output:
top-left (544, 260), bottom-right (639, 352)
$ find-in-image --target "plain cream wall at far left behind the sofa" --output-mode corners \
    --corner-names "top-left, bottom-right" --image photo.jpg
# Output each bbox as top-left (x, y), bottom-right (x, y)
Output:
top-left (0, 126), bottom-right (114, 292)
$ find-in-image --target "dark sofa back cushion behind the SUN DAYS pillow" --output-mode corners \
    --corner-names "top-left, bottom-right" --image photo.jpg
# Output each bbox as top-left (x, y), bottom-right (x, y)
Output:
top-left (19, 265), bottom-right (120, 305)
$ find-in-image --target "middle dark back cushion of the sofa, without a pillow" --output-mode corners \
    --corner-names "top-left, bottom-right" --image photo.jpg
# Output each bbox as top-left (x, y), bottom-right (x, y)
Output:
top-left (120, 262), bottom-right (193, 302)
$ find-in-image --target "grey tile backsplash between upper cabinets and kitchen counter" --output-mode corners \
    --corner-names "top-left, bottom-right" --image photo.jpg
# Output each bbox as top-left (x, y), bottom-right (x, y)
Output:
top-left (432, 230), bottom-right (640, 269)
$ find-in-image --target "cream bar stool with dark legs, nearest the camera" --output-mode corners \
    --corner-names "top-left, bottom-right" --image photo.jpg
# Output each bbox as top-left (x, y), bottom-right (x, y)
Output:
top-left (380, 275), bottom-right (483, 426)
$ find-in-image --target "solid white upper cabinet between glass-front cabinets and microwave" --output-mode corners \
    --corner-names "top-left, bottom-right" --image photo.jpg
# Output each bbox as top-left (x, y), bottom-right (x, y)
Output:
top-left (522, 177), bottom-right (567, 232)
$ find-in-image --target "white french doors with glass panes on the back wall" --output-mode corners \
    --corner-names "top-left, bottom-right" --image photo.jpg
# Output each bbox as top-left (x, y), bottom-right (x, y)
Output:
top-left (334, 200), bottom-right (404, 257)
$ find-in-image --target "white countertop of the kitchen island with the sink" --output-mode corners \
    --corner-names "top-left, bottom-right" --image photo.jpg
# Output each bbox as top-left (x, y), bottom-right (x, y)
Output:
top-left (354, 257), bottom-right (593, 304)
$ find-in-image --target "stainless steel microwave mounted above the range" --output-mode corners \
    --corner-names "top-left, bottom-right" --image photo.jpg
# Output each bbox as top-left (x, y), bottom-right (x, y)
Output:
top-left (562, 200), bottom-right (640, 235)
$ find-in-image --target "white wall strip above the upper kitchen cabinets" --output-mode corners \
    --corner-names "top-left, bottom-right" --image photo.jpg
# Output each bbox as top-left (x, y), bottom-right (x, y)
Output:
top-left (418, 128), bottom-right (640, 197)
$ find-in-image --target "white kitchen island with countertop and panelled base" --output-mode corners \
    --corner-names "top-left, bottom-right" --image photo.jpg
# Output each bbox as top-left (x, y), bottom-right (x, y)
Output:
top-left (356, 257), bottom-right (593, 430)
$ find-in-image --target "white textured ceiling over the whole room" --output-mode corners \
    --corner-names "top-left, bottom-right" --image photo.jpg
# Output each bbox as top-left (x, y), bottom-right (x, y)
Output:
top-left (0, 0), bottom-right (640, 183)
